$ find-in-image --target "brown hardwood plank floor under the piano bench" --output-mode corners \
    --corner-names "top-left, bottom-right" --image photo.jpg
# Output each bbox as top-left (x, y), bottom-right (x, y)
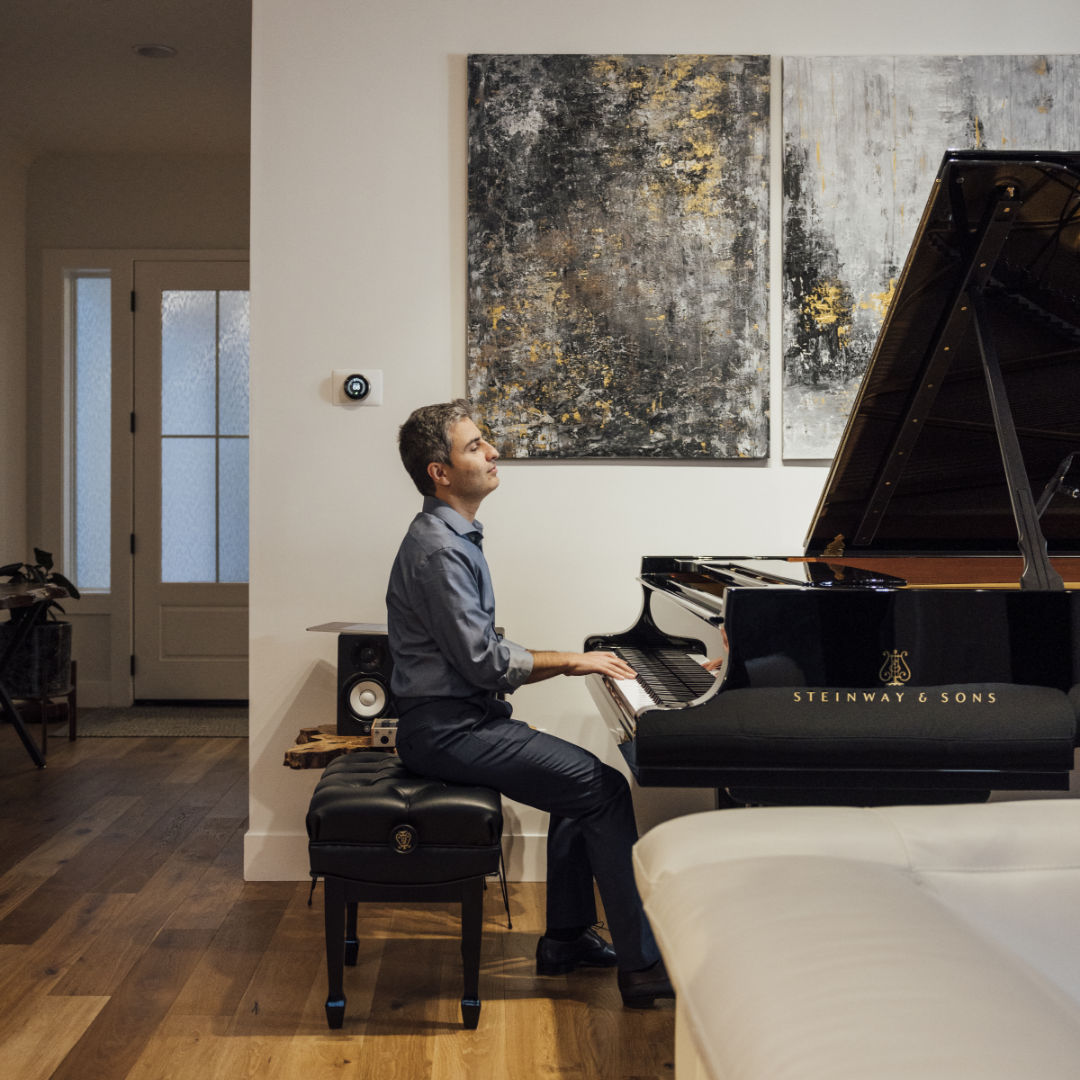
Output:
top-left (0, 725), bottom-right (675, 1080)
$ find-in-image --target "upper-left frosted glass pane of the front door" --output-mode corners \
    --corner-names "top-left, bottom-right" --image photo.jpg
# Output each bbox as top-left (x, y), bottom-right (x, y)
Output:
top-left (161, 291), bottom-right (217, 436)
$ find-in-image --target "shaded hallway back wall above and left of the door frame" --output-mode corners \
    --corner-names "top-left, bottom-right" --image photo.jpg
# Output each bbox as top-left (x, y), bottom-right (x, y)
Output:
top-left (25, 153), bottom-right (249, 707)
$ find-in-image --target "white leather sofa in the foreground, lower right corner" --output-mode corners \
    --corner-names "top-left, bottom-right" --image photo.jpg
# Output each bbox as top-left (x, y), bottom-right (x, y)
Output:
top-left (634, 799), bottom-right (1080, 1080)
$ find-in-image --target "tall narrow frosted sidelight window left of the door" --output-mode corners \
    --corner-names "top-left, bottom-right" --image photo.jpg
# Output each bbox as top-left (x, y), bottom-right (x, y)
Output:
top-left (72, 278), bottom-right (112, 590)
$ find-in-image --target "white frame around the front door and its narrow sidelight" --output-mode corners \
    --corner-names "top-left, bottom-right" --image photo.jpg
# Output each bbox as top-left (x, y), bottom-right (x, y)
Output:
top-left (40, 248), bottom-right (249, 707)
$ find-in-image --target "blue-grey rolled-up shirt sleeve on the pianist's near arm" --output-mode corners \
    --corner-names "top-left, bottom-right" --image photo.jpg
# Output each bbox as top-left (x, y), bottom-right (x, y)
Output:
top-left (410, 548), bottom-right (532, 693)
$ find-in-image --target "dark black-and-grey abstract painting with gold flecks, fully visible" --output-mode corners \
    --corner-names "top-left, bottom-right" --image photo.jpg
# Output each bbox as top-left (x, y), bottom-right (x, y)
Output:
top-left (468, 55), bottom-right (769, 459)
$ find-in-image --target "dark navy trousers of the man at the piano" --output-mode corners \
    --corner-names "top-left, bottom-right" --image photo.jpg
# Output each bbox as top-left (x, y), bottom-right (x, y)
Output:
top-left (397, 694), bottom-right (660, 971)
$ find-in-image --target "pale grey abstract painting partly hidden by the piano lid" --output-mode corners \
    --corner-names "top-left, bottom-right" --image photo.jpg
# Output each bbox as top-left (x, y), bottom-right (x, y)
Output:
top-left (783, 56), bottom-right (1080, 458)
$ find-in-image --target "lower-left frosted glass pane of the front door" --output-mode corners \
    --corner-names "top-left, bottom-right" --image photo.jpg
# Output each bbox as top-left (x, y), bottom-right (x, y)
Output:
top-left (161, 438), bottom-right (217, 581)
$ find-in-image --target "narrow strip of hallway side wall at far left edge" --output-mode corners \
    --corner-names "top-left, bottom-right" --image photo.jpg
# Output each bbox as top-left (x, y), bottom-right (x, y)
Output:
top-left (0, 135), bottom-right (30, 565)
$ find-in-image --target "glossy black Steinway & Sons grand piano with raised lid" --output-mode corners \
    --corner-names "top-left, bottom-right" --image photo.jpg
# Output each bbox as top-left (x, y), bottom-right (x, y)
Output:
top-left (585, 151), bottom-right (1080, 805)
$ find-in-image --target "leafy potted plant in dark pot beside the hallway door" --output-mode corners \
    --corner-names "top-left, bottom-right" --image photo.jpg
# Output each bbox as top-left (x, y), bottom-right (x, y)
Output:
top-left (0, 548), bottom-right (79, 701)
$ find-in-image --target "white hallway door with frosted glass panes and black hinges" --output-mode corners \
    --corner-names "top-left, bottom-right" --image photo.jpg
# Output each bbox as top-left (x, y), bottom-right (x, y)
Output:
top-left (132, 262), bottom-right (248, 701)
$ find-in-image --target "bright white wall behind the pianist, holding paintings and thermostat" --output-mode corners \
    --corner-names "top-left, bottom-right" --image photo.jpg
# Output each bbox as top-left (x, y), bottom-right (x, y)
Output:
top-left (246, 0), bottom-right (1080, 879)
